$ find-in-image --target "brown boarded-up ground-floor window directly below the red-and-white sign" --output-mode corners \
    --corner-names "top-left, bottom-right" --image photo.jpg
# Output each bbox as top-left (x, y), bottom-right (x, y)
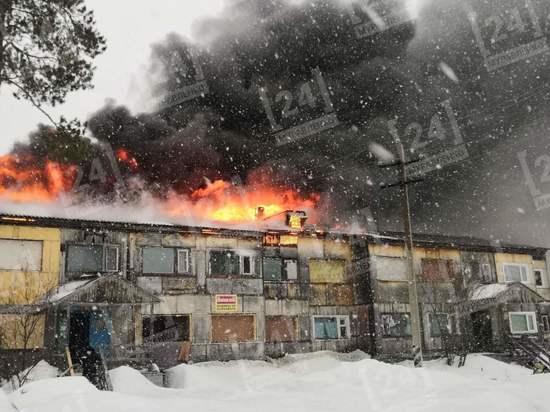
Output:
top-left (212, 315), bottom-right (254, 343)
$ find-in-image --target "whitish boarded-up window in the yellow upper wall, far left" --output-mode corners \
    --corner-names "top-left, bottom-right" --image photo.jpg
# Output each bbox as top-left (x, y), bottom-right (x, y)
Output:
top-left (0, 239), bottom-right (42, 272)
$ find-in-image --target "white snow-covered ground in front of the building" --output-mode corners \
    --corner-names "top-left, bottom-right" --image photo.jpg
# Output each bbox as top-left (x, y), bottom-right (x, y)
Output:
top-left (0, 352), bottom-right (550, 412)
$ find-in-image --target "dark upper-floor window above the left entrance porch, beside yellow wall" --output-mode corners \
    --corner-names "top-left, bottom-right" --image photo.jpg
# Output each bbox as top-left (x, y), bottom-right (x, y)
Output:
top-left (67, 245), bottom-right (119, 273)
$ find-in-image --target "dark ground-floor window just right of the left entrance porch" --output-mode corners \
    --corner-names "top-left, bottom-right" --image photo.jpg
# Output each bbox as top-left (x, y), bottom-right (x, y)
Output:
top-left (142, 315), bottom-right (190, 343)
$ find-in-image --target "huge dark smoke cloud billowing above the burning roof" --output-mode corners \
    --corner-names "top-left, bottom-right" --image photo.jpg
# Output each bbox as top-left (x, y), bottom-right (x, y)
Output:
top-left (10, 0), bottom-right (550, 242)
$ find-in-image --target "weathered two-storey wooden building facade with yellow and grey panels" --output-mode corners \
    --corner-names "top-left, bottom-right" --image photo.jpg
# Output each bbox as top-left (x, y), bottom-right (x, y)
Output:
top-left (0, 216), bottom-right (550, 374)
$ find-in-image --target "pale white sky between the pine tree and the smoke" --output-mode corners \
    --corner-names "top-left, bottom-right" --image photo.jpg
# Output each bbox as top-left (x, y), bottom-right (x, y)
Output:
top-left (0, 0), bottom-right (224, 154)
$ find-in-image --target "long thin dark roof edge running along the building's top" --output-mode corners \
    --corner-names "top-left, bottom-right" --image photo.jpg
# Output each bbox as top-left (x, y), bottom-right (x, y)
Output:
top-left (0, 212), bottom-right (548, 259)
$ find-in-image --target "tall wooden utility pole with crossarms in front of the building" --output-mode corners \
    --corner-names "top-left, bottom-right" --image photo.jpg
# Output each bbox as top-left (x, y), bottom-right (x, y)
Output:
top-left (381, 138), bottom-right (423, 366)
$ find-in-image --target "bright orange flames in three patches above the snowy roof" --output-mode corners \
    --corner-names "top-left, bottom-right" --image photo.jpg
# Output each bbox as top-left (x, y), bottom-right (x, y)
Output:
top-left (0, 154), bottom-right (319, 224)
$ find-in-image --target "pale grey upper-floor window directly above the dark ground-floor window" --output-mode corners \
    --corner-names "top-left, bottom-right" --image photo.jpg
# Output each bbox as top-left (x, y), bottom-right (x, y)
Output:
top-left (142, 246), bottom-right (191, 275)
